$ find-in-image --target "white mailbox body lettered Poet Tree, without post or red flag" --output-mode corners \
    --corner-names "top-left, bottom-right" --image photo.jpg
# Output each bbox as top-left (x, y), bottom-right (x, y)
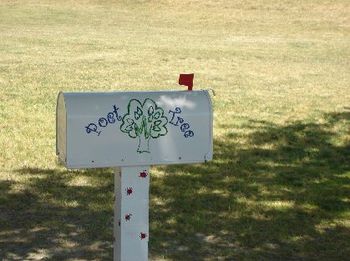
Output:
top-left (56, 90), bottom-right (213, 168)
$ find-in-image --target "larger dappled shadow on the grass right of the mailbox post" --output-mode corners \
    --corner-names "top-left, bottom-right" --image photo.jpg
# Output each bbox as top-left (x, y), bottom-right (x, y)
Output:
top-left (150, 112), bottom-right (350, 260)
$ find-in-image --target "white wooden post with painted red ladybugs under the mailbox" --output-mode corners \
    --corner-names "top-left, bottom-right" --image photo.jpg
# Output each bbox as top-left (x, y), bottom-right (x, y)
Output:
top-left (113, 166), bottom-right (150, 261)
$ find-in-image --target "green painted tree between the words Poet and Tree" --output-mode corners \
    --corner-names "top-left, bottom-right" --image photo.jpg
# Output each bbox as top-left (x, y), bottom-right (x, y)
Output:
top-left (120, 98), bottom-right (168, 153)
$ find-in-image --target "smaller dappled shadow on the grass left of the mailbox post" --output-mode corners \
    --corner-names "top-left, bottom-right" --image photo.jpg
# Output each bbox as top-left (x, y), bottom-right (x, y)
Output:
top-left (0, 168), bottom-right (114, 260)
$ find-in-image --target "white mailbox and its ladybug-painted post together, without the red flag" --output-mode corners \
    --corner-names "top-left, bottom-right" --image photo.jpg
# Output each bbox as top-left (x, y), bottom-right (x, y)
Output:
top-left (56, 90), bottom-right (213, 261)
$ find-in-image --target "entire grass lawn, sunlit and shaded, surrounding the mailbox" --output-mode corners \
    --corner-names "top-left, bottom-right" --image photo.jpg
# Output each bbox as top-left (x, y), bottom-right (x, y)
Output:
top-left (0, 0), bottom-right (350, 260)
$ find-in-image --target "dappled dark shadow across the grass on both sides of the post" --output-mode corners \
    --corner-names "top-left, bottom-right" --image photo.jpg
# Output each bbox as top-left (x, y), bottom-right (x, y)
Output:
top-left (0, 112), bottom-right (350, 260)
